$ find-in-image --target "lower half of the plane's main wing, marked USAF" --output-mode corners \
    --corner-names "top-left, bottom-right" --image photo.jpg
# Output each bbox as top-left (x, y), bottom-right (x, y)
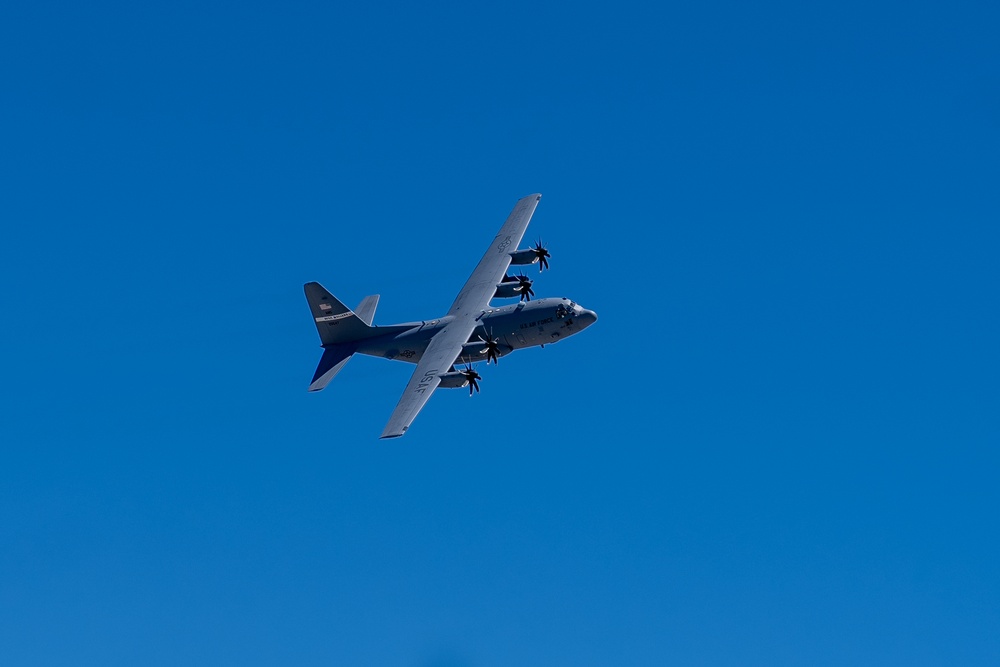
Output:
top-left (381, 317), bottom-right (476, 438)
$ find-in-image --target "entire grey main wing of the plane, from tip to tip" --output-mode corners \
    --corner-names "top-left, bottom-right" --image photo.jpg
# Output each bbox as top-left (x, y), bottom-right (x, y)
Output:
top-left (382, 194), bottom-right (542, 438)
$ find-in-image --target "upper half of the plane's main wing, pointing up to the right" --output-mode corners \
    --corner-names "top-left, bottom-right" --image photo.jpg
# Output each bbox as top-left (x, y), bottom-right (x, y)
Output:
top-left (448, 194), bottom-right (542, 315)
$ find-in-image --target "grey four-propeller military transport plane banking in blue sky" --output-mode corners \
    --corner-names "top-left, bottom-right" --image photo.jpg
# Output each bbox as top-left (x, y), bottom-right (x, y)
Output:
top-left (304, 194), bottom-right (597, 439)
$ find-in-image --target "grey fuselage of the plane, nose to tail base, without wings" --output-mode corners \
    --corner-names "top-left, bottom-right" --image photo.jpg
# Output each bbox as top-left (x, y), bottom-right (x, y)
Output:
top-left (357, 298), bottom-right (597, 364)
